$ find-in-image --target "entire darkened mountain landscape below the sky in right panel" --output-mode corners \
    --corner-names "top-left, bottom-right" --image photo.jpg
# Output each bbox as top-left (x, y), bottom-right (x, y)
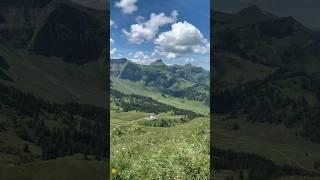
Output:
top-left (211, 6), bottom-right (320, 179)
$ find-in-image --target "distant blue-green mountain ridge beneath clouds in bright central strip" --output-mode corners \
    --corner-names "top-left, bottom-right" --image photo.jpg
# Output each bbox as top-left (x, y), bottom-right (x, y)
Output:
top-left (110, 58), bottom-right (210, 103)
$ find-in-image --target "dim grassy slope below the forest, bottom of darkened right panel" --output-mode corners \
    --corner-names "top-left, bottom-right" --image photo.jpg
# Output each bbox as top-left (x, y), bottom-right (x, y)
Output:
top-left (212, 115), bottom-right (320, 180)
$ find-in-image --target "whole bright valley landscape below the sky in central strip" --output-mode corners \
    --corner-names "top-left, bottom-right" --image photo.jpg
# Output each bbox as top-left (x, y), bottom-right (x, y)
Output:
top-left (110, 58), bottom-right (210, 180)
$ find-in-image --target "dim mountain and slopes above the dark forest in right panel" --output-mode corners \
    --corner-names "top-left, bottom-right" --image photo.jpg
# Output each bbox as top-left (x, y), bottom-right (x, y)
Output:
top-left (212, 6), bottom-right (320, 118)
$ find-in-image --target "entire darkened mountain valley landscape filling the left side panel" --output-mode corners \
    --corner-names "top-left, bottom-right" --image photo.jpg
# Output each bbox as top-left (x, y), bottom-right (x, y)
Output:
top-left (0, 0), bottom-right (108, 180)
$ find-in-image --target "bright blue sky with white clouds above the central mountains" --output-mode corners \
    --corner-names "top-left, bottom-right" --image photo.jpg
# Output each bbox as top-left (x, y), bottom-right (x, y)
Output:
top-left (110, 0), bottom-right (210, 69)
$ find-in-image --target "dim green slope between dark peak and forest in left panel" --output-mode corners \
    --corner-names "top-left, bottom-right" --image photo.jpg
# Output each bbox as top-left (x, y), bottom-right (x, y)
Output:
top-left (0, 45), bottom-right (107, 107)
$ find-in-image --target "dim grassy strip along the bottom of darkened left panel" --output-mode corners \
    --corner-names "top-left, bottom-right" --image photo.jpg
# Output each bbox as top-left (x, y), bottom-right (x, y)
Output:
top-left (0, 155), bottom-right (106, 180)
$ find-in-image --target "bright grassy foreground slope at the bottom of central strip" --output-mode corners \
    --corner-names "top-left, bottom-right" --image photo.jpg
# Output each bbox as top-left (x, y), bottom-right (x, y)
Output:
top-left (111, 118), bottom-right (210, 180)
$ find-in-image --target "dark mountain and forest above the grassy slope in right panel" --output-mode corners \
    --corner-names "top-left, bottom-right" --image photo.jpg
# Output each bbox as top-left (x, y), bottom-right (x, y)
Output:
top-left (211, 6), bottom-right (320, 146)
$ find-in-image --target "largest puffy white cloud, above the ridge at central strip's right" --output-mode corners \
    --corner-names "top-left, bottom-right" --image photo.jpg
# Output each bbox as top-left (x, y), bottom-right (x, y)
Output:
top-left (154, 21), bottom-right (210, 59)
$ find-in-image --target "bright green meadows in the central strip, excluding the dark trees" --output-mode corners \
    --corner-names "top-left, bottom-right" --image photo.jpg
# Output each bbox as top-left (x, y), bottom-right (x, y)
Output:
top-left (110, 85), bottom-right (210, 180)
